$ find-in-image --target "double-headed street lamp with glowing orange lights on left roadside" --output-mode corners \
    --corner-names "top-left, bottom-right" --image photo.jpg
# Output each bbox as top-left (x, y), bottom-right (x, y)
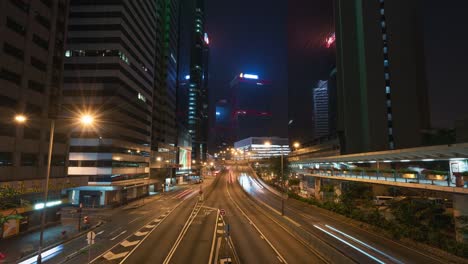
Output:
top-left (15, 114), bottom-right (94, 264)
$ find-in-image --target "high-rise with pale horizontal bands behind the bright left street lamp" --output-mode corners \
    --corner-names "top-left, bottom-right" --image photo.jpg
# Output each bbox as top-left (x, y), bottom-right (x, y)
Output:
top-left (63, 0), bottom-right (158, 205)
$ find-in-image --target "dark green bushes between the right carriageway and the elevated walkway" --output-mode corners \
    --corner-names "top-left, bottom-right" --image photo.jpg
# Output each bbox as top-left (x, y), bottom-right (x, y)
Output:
top-left (289, 183), bottom-right (468, 258)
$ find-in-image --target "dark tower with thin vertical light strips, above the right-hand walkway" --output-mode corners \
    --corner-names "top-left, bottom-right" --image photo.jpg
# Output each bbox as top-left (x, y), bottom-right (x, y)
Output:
top-left (335, 0), bottom-right (429, 153)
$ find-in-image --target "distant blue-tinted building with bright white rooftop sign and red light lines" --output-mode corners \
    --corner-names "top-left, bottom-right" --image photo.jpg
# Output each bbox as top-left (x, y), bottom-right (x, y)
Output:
top-left (230, 73), bottom-right (272, 140)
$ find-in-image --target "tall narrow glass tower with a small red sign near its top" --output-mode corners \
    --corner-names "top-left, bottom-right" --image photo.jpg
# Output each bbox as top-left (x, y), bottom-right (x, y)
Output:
top-left (187, 0), bottom-right (210, 161)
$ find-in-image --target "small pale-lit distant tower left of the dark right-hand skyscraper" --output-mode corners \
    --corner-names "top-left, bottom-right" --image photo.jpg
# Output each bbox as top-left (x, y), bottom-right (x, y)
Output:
top-left (313, 80), bottom-right (330, 138)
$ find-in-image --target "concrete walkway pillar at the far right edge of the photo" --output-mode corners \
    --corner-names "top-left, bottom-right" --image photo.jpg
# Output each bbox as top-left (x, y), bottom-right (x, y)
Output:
top-left (453, 194), bottom-right (468, 243)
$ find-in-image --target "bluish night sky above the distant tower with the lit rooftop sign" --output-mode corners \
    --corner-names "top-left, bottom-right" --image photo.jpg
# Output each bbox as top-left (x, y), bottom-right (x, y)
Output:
top-left (206, 0), bottom-right (288, 139)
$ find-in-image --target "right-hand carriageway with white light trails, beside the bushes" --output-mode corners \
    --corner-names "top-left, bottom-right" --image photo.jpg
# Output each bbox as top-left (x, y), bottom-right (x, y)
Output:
top-left (239, 169), bottom-right (458, 263)
